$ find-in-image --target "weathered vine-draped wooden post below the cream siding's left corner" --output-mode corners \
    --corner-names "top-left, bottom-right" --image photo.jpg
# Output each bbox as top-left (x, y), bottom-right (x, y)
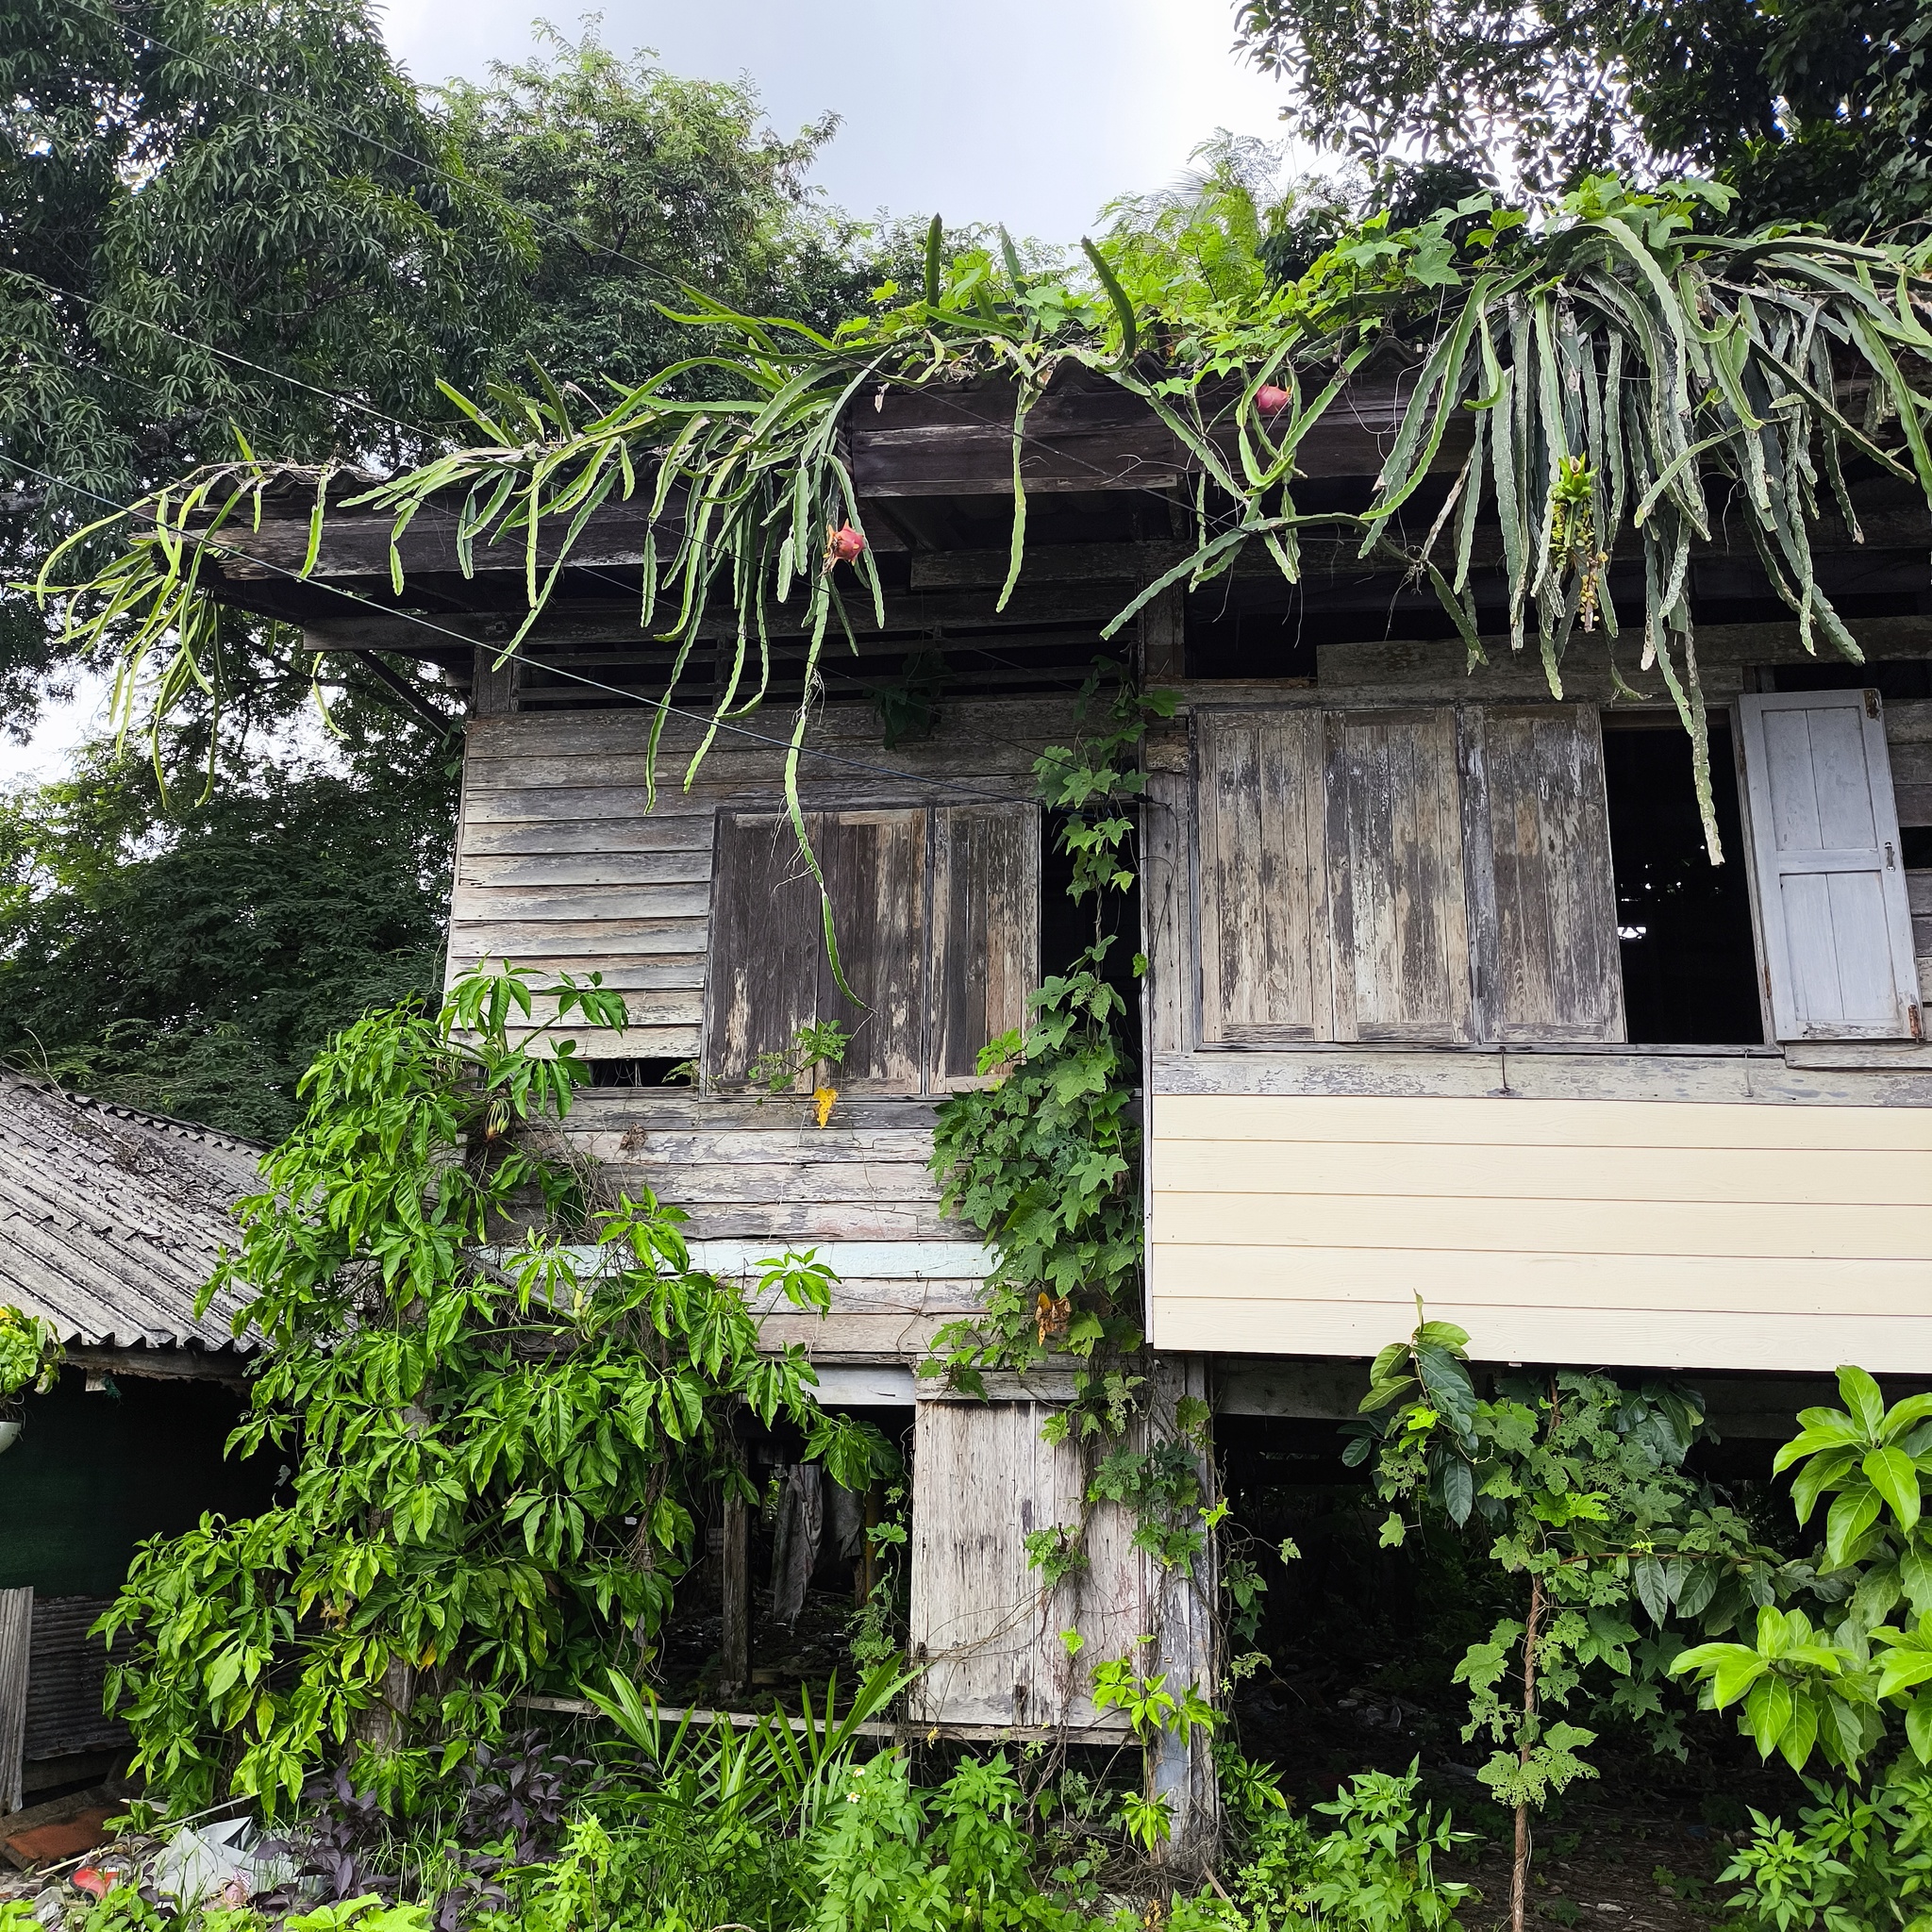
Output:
top-left (1141, 1355), bottom-right (1221, 1874)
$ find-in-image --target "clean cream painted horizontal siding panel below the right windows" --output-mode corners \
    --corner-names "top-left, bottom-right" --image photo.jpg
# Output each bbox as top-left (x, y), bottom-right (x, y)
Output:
top-left (1148, 1095), bottom-right (1932, 1374)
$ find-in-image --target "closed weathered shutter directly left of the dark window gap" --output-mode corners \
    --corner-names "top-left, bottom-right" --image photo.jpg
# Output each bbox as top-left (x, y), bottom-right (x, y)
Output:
top-left (1460, 706), bottom-right (1624, 1041)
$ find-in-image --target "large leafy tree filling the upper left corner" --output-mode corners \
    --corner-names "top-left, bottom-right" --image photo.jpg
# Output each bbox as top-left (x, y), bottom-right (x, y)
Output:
top-left (0, 0), bottom-right (531, 719)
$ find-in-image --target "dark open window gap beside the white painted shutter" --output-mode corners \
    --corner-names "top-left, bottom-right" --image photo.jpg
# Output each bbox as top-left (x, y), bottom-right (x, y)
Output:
top-left (1604, 719), bottom-right (1764, 1047)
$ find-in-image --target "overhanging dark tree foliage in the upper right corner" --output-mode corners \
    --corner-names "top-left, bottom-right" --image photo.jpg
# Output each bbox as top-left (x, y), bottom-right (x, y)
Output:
top-left (1237, 0), bottom-right (1932, 236)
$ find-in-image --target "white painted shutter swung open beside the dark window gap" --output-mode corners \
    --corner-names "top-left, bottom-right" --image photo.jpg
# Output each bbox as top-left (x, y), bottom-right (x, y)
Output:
top-left (1739, 691), bottom-right (1923, 1040)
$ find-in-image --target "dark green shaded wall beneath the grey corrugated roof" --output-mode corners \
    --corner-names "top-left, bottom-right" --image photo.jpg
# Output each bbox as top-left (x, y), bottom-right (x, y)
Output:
top-left (0, 1370), bottom-right (284, 1596)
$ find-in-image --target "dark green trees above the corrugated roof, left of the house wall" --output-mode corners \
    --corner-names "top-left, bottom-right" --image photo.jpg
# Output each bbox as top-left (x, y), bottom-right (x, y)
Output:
top-left (0, 722), bottom-right (456, 1141)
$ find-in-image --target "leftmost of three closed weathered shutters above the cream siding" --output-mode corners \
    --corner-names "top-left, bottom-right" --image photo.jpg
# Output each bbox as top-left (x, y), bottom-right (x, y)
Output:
top-left (1194, 709), bottom-right (1335, 1043)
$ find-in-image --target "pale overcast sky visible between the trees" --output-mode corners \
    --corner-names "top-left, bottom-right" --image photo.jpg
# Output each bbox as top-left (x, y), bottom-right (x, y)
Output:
top-left (0, 0), bottom-right (1306, 784)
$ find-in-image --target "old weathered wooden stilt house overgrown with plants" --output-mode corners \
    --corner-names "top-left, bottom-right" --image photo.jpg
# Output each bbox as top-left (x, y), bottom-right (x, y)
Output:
top-left (177, 380), bottom-right (1932, 1839)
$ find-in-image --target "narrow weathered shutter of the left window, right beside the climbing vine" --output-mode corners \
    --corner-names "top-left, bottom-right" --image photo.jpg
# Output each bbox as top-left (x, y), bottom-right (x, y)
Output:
top-left (927, 806), bottom-right (1040, 1091)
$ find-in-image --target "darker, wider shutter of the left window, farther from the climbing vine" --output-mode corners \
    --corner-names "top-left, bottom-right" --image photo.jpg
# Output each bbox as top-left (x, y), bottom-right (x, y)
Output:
top-left (706, 809), bottom-right (925, 1093)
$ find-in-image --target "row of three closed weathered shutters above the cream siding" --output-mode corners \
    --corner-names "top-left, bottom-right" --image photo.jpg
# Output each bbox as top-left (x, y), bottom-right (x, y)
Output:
top-left (1190, 701), bottom-right (1623, 1047)
